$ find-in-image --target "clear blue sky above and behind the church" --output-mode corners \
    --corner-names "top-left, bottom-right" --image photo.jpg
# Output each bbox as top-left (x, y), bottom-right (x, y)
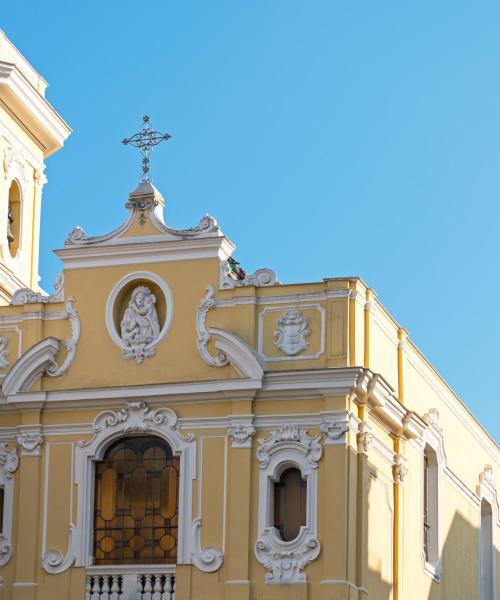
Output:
top-left (0, 0), bottom-right (500, 439)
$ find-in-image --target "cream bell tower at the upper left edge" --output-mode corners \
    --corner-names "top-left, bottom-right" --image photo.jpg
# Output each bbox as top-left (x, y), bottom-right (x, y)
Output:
top-left (0, 30), bottom-right (71, 305)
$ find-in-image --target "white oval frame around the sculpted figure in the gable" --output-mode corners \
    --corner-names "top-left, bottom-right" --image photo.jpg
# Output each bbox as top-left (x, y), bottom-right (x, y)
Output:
top-left (105, 271), bottom-right (174, 360)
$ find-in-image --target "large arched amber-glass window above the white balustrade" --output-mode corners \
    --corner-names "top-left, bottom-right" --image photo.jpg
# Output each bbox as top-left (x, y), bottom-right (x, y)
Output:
top-left (94, 436), bottom-right (179, 565)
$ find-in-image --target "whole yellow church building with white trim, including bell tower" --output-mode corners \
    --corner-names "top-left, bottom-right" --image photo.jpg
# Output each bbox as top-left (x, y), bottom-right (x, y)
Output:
top-left (0, 34), bottom-right (500, 600)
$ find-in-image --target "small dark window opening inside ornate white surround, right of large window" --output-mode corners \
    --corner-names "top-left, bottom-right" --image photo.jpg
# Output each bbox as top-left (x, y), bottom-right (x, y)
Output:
top-left (274, 467), bottom-right (307, 542)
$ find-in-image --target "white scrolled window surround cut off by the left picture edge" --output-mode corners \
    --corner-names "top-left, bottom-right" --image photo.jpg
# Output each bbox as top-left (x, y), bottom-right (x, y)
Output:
top-left (0, 442), bottom-right (19, 566)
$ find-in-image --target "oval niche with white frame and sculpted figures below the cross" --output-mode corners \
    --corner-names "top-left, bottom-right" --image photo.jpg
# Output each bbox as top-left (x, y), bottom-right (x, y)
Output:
top-left (106, 271), bottom-right (173, 365)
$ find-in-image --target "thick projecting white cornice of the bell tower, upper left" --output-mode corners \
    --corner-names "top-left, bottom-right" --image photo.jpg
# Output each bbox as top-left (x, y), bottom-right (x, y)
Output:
top-left (0, 61), bottom-right (71, 157)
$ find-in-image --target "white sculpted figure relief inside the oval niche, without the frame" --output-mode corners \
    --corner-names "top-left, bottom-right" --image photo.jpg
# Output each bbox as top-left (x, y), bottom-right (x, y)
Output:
top-left (120, 285), bottom-right (160, 365)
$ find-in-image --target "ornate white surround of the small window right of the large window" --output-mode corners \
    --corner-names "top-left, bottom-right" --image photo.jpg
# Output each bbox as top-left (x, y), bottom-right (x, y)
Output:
top-left (255, 425), bottom-right (323, 584)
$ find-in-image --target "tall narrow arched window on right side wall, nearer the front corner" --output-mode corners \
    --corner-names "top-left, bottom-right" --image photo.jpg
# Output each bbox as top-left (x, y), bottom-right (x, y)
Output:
top-left (423, 444), bottom-right (439, 565)
